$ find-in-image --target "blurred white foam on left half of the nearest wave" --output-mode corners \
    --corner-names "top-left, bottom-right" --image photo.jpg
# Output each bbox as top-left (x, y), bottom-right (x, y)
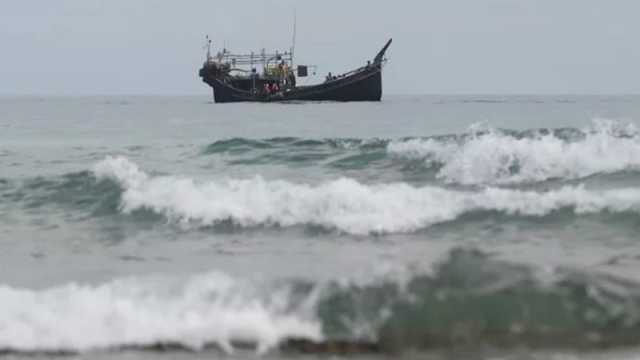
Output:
top-left (0, 274), bottom-right (321, 352)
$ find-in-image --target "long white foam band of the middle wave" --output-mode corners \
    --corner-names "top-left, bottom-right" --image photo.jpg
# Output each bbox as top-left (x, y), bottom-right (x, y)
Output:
top-left (95, 157), bottom-right (640, 235)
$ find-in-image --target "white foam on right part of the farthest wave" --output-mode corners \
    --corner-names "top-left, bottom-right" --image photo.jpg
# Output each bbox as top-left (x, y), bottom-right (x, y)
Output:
top-left (387, 121), bottom-right (640, 185)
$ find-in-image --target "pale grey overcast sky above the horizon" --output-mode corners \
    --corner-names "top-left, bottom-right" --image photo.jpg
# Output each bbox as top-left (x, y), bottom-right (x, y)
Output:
top-left (0, 0), bottom-right (640, 95)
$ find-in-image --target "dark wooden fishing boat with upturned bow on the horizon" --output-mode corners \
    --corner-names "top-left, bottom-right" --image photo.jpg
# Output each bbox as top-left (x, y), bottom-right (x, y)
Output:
top-left (199, 38), bottom-right (392, 103)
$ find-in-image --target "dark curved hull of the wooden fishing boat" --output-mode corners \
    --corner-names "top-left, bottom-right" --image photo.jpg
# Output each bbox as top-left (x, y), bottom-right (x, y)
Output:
top-left (200, 64), bottom-right (382, 103)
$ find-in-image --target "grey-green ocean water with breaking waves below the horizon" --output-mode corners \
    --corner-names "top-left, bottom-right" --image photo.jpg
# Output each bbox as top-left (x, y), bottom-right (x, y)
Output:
top-left (0, 95), bottom-right (640, 359)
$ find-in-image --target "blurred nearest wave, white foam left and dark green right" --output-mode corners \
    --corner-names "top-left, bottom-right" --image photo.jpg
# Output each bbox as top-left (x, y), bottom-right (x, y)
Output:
top-left (0, 249), bottom-right (640, 353)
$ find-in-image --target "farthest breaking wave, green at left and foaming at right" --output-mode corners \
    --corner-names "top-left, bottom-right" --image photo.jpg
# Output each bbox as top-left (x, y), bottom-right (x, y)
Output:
top-left (202, 120), bottom-right (640, 185)
